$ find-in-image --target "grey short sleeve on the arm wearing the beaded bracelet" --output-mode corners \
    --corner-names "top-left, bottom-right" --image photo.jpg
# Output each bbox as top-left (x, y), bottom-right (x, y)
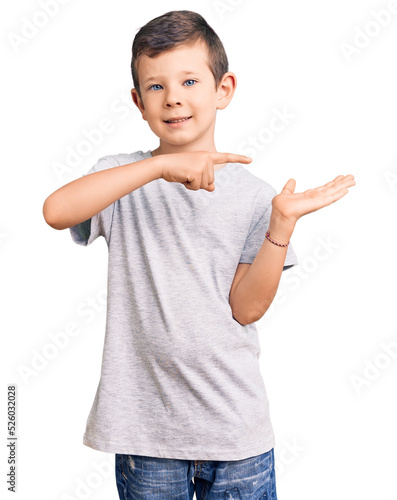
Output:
top-left (239, 188), bottom-right (298, 271)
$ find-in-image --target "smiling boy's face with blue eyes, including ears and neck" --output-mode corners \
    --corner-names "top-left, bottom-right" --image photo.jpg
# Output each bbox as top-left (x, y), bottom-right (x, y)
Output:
top-left (131, 40), bottom-right (235, 150)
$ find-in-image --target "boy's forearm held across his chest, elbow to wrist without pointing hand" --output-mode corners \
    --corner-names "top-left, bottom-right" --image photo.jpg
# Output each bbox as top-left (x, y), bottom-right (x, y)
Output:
top-left (43, 156), bottom-right (161, 229)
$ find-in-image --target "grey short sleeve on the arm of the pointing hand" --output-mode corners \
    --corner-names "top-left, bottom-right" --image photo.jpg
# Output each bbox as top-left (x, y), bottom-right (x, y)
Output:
top-left (69, 155), bottom-right (119, 246)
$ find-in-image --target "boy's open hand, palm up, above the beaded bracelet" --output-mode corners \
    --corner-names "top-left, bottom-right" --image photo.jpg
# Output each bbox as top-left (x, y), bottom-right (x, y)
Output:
top-left (272, 174), bottom-right (356, 224)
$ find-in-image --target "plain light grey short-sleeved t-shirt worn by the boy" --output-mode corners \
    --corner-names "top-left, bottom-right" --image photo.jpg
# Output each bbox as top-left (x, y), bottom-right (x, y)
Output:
top-left (70, 150), bottom-right (298, 460)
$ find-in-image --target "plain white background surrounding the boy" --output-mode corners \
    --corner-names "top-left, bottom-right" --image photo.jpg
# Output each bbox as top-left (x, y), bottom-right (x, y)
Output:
top-left (0, 0), bottom-right (397, 500)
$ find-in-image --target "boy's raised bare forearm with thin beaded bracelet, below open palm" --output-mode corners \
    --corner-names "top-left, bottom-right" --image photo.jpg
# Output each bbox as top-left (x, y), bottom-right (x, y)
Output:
top-left (230, 213), bottom-right (295, 324)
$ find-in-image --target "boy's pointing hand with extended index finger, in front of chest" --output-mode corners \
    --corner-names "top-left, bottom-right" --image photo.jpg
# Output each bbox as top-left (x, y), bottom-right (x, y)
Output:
top-left (159, 151), bottom-right (252, 191)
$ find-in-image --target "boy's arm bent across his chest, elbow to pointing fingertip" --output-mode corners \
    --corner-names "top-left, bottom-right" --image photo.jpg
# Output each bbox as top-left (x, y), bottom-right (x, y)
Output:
top-left (43, 151), bottom-right (252, 229)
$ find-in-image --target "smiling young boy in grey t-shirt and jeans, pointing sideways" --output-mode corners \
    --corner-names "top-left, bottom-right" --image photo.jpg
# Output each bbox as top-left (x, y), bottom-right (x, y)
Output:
top-left (43, 10), bottom-right (354, 500)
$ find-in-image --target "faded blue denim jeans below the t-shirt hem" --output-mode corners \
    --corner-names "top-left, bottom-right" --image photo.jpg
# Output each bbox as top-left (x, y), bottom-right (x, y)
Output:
top-left (115, 448), bottom-right (277, 500)
